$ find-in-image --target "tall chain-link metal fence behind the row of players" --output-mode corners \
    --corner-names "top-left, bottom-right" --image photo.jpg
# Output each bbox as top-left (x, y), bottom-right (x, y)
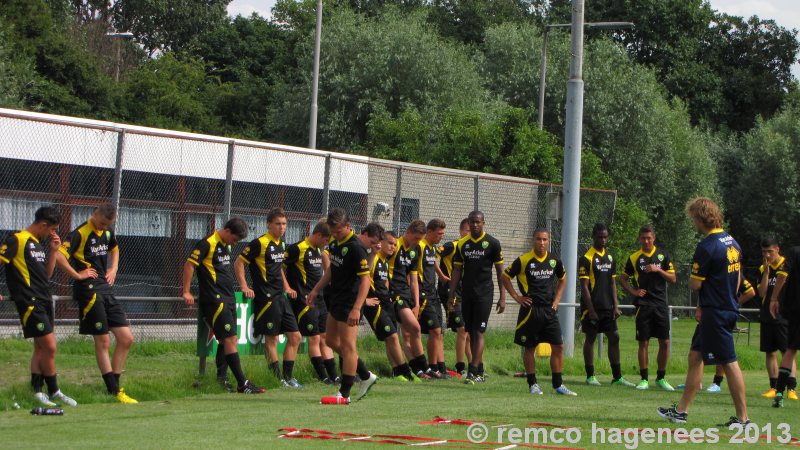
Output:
top-left (0, 109), bottom-right (616, 339)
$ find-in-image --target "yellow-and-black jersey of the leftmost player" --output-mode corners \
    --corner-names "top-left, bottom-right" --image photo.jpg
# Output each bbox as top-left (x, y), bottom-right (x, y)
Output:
top-left (0, 230), bottom-right (50, 301)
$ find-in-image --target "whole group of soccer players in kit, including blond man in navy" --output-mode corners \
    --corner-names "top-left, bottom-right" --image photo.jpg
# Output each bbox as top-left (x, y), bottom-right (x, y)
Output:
top-left (0, 199), bottom-right (800, 423)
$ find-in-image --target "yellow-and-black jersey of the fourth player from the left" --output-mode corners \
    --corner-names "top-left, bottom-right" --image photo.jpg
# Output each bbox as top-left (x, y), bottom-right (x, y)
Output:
top-left (239, 233), bottom-right (286, 299)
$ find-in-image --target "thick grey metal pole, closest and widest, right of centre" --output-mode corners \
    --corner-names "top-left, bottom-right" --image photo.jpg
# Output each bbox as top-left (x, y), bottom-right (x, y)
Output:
top-left (559, 0), bottom-right (583, 356)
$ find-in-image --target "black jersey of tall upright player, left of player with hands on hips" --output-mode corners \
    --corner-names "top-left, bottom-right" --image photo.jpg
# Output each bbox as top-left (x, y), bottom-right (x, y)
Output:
top-left (453, 233), bottom-right (503, 302)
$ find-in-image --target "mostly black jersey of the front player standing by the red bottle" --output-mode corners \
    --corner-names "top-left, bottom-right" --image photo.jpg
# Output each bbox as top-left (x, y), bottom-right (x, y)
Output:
top-left (325, 231), bottom-right (369, 305)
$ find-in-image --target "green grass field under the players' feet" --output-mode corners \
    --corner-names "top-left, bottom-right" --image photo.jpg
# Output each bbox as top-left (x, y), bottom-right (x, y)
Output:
top-left (0, 318), bottom-right (800, 448)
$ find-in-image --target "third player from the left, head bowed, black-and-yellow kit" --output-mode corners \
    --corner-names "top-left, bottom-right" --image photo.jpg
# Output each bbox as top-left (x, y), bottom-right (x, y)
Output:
top-left (182, 218), bottom-right (266, 394)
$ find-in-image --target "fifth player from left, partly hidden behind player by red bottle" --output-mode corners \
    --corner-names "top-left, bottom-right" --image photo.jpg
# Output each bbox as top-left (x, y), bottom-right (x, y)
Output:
top-left (283, 221), bottom-right (336, 384)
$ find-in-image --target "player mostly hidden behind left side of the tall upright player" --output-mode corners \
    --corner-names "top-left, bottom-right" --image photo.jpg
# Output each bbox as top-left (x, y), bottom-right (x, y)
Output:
top-left (438, 218), bottom-right (472, 376)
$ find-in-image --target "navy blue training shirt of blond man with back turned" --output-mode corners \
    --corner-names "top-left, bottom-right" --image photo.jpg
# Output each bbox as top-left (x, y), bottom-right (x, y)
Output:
top-left (692, 228), bottom-right (742, 311)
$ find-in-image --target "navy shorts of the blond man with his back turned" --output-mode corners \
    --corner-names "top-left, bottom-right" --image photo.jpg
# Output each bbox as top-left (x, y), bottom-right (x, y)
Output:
top-left (691, 308), bottom-right (738, 365)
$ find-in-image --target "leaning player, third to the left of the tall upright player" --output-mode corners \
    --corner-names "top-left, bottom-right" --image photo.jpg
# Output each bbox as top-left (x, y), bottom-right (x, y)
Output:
top-left (388, 220), bottom-right (436, 380)
